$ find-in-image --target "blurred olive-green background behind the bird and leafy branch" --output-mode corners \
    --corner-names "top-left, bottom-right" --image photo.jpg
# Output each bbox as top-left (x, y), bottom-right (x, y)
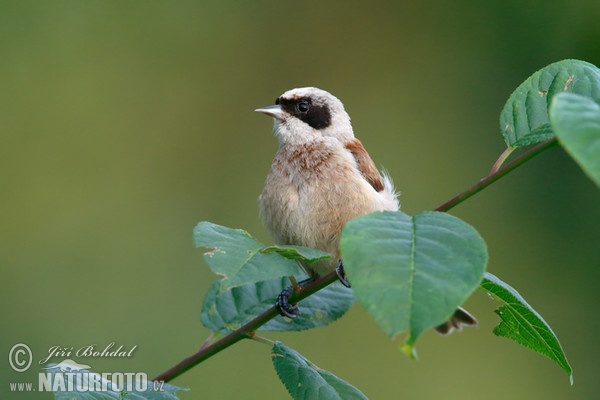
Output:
top-left (0, 0), bottom-right (600, 399)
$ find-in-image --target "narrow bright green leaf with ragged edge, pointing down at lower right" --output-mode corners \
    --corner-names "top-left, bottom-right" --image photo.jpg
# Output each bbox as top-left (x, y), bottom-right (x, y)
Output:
top-left (481, 273), bottom-right (573, 385)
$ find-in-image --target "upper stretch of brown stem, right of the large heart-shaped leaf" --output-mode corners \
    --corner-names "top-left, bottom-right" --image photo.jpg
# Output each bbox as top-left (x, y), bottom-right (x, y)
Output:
top-left (434, 138), bottom-right (558, 211)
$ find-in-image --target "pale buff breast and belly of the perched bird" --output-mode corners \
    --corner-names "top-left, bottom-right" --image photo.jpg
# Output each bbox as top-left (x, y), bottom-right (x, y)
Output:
top-left (259, 139), bottom-right (398, 276)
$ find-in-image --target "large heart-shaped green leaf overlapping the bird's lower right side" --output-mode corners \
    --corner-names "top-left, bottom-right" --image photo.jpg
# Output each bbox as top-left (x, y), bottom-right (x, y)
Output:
top-left (340, 211), bottom-right (487, 353)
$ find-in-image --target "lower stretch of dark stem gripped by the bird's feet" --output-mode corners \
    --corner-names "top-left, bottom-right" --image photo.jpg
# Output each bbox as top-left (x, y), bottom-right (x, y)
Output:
top-left (152, 271), bottom-right (338, 382)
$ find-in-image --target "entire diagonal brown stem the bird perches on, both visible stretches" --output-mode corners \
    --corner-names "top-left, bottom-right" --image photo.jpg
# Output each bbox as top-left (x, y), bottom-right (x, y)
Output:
top-left (153, 138), bottom-right (557, 382)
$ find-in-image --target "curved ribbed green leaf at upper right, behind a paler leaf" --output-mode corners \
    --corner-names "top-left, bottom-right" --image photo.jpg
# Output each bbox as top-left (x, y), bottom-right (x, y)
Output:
top-left (500, 60), bottom-right (600, 147)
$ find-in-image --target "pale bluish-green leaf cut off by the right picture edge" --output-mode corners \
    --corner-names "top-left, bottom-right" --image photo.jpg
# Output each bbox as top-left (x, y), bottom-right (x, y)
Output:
top-left (550, 93), bottom-right (600, 186)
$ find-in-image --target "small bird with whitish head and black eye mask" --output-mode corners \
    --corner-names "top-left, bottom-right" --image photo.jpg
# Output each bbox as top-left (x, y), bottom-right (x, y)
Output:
top-left (255, 87), bottom-right (477, 334)
